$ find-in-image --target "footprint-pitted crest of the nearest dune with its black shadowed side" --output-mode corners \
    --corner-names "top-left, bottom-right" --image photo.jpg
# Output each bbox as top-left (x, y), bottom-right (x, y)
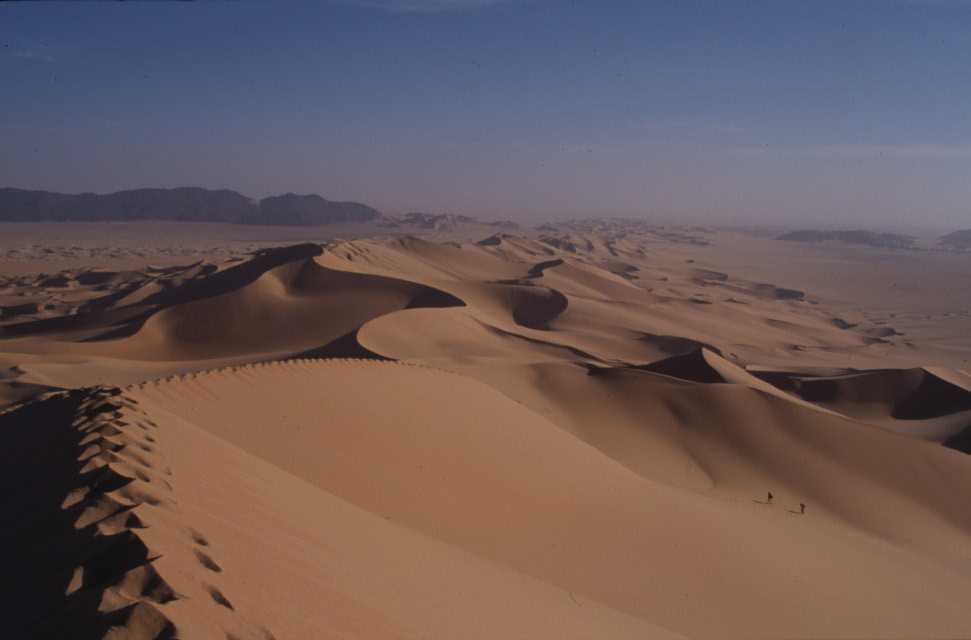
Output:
top-left (0, 387), bottom-right (272, 638)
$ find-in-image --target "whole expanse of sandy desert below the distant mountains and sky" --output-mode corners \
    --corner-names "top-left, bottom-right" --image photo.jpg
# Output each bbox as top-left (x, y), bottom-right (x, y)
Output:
top-left (0, 223), bottom-right (971, 639)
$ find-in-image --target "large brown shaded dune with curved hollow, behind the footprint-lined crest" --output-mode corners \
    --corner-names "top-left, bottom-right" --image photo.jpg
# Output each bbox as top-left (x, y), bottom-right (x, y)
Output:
top-left (5, 244), bottom-right (465, 360)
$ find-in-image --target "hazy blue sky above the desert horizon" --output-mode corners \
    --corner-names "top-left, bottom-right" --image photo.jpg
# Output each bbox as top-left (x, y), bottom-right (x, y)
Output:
top-left (0, 0), bottom-right (971, 230)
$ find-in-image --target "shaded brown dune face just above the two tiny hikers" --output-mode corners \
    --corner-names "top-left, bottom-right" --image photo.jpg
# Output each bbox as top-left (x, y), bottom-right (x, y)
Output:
top-left (474, 363), bottom-right (971, 554)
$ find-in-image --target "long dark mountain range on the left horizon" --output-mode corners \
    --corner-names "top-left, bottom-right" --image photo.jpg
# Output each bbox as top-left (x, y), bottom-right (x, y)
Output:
top-left (0, 187), bottom-right (381, 225)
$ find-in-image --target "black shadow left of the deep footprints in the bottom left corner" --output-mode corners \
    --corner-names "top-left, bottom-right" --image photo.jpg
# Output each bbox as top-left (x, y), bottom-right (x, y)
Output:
top-left (0, 392), bottom-right (175, 638)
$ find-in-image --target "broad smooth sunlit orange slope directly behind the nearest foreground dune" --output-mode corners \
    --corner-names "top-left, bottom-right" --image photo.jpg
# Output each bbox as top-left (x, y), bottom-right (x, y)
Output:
top-left (125, 360), bottom-right (971, 636)
